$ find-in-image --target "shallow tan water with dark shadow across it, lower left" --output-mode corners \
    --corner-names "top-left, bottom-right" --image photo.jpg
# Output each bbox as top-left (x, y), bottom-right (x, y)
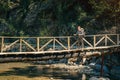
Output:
top-left (0, 62), bottom-right (86, 80)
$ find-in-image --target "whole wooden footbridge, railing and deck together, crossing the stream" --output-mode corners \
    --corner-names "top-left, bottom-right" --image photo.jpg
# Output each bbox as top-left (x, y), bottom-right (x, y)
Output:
top-left (0, 34), bottom-right (120, 58)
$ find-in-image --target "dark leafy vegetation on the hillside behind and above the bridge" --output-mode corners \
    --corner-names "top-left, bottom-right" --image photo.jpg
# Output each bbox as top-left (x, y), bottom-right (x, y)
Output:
top-left (0, 0), bottom-right (120, 36)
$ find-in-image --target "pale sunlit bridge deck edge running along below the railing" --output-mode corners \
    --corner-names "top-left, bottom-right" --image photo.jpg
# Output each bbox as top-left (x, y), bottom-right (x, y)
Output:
top-left (0, 45), bottom-right (120, 55)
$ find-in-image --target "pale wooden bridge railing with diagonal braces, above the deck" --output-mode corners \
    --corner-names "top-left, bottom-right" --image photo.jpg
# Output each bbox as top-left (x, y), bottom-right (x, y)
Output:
top-left (0, 34), bottom-right (120, 53)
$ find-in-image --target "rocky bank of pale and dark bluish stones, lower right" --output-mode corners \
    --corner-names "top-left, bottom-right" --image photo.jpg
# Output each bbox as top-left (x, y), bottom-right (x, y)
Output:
top-left (32, 53), bottom-right (120, 80)
